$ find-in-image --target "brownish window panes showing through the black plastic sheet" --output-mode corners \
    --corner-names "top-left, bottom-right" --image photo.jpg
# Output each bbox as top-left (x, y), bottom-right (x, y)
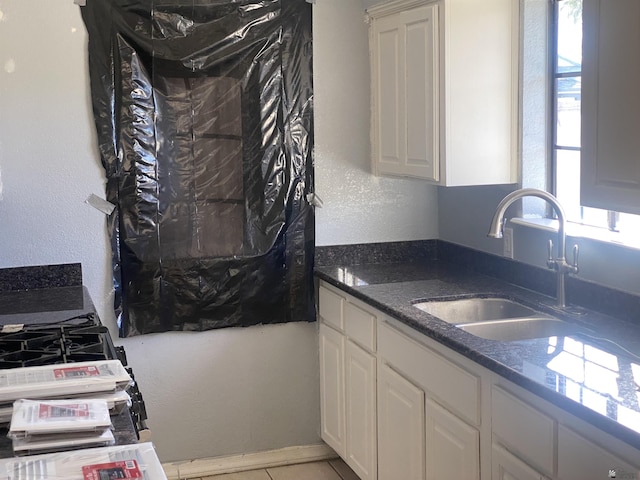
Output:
top-left (153, 74), bottom-right (245, 259)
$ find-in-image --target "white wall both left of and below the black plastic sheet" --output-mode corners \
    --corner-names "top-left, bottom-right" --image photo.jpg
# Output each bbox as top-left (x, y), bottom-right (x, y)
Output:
top-left (0, 0), bottom-right (320, 461)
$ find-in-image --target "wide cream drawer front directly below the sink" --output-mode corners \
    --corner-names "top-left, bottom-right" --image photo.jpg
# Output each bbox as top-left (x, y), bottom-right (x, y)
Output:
top-left (378, 323), bottom-right (480, 425)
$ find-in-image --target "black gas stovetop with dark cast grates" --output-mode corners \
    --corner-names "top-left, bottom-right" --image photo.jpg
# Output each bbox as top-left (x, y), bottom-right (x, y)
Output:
top-left (0, 319), bottom-right (118, 369)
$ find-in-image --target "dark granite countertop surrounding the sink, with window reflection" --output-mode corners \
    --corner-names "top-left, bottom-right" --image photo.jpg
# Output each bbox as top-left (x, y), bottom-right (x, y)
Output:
top-left (316, 259), bottom-right (640, 448)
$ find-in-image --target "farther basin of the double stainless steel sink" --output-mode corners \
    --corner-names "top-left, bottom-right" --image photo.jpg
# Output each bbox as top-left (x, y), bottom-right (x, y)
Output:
top-left (413, 298), bottom-right (540, 324)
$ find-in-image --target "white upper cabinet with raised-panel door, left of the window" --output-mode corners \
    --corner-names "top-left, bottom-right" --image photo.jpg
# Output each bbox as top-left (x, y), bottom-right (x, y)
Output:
top-left (367, 0), bottom-right (519, 186)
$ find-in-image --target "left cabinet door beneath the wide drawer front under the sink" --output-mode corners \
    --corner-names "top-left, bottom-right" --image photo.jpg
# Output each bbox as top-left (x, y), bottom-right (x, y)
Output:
top-left (378, 365), bottom-right (424, 480)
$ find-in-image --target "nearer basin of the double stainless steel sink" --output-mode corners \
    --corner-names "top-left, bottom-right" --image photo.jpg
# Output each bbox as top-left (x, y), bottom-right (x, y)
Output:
top-left (457, 317), bottom-right (582, 342)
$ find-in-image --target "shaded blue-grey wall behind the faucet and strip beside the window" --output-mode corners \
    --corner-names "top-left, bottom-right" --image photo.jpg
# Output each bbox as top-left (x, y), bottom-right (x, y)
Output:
top-left (440, 0), bottom-right (640, 295)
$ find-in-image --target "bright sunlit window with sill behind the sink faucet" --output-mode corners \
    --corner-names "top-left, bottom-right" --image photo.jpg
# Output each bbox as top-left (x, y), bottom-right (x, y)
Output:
top-left (551, 0), bottom-right (640, 241)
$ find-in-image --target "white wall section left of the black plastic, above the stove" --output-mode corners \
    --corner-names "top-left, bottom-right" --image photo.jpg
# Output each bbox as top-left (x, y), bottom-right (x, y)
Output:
top-left (0, 0), bottom-right (108, 314)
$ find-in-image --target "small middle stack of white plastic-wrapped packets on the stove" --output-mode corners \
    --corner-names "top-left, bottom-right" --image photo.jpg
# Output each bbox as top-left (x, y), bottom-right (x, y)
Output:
top-left (8, 399), bottom-right (115, 455)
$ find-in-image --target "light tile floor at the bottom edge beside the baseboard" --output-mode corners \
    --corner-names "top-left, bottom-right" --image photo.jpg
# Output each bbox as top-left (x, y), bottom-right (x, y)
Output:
top-left (200, 459), bottom-right (360, 480)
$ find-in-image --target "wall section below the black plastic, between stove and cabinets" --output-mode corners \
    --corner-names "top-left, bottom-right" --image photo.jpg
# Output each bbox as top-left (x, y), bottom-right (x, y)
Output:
top-left (120, 323), bottom-right (320, 461)
